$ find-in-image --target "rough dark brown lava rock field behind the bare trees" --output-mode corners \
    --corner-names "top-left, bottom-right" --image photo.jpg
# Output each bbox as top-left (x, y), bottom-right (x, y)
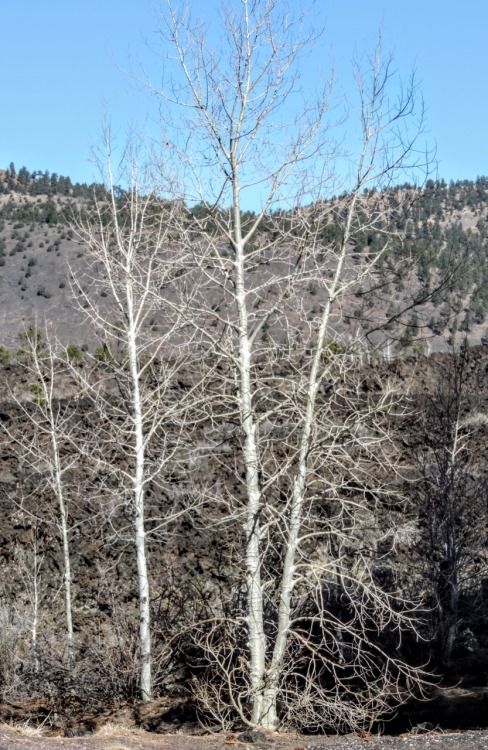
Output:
top-left (0, 347), bottom-right (488, 736)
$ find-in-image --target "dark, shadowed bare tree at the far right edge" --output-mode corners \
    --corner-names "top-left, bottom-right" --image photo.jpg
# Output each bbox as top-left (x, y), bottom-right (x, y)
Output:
top-left (413, 347), bottom-right (488, 664)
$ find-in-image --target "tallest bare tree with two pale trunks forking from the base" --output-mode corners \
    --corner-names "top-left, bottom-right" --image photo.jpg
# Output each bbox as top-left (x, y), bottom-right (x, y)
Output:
top-left (132, 0), bottom-right (428, 728)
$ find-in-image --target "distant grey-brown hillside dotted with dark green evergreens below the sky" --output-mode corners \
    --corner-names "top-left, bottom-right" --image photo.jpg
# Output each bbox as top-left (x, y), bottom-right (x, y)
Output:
top-left (0, 164), bottom-right (488, 355)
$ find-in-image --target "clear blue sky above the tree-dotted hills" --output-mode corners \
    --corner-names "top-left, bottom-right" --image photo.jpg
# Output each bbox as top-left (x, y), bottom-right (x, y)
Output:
top-left (0, 0), bottom-right (488, 187)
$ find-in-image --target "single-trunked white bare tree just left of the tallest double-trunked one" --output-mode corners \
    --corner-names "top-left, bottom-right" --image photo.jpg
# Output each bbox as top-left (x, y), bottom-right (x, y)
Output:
top-left (72, 153), bottom-right (202, 701)
